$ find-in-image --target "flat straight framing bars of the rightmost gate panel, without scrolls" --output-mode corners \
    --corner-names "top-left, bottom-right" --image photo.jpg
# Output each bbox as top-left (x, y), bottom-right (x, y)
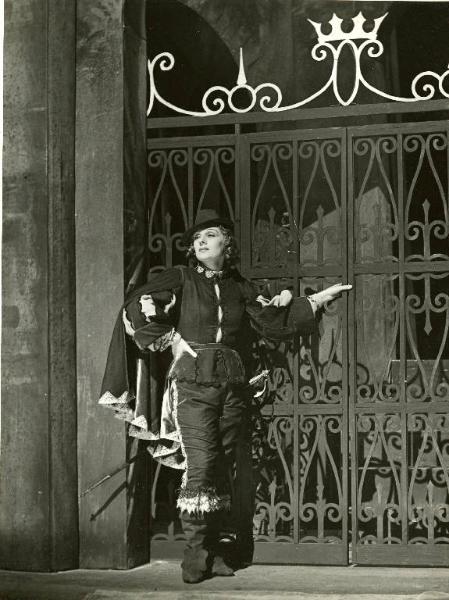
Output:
top-left (347, 120), bottom-right (449, 566)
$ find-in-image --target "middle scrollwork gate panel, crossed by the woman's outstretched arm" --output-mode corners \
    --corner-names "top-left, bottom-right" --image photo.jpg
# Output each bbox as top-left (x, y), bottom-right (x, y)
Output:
top-left (241, 129), bottom-right (348, 564)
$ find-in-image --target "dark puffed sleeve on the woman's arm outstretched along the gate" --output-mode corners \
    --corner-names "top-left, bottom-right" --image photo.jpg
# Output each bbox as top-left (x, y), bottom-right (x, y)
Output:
top-left (243, 280), bottom-right (318, 341)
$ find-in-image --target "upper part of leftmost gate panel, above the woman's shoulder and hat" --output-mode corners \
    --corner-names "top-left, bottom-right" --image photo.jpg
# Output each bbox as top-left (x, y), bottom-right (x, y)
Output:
top-left (148, 135), bottom-right (239, 271)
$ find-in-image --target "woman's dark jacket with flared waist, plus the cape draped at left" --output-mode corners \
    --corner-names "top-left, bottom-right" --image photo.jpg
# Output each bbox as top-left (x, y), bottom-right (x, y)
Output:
top-left (100, 267), bottom-right (317, 460)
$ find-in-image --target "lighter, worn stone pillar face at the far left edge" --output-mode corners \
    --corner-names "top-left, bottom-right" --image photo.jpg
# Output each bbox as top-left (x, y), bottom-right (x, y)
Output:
top-left (0, 0), bottom-right (78, 571)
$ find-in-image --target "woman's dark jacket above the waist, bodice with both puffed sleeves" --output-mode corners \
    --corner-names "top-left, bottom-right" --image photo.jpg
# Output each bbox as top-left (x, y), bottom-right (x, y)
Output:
top-left (125, 267), bottom-right (316, 348)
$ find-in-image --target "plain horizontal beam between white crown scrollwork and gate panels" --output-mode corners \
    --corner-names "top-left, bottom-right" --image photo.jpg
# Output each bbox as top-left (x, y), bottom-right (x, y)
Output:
top-left (147, 99), bottom-right (449, 129)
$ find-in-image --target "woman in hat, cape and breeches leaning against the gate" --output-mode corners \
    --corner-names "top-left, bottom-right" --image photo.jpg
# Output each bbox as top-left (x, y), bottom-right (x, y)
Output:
top-left (100, 210), bottom-right (351, 583)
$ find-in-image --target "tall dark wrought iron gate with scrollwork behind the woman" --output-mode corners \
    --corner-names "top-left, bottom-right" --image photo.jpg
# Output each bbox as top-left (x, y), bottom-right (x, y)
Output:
top-left (148, 110), bottom-right (449, 565)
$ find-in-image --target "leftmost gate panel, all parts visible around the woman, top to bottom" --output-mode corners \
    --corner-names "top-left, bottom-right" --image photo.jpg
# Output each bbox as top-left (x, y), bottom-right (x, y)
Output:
top-left (146, 135), bottom-right (240, 559)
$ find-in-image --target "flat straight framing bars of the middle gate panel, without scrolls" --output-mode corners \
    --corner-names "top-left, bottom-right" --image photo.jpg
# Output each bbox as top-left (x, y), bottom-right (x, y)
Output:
top-left (241, 128), bottom-right (348, 564)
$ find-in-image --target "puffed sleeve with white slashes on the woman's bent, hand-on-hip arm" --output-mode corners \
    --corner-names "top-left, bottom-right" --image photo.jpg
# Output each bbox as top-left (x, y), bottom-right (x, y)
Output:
top-left (122, 268), bottom-right (182, 351)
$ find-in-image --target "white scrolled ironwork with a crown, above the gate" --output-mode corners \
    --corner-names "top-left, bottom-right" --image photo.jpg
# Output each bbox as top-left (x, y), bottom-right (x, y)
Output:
top-left (147, 12), bottom-right (449, 117)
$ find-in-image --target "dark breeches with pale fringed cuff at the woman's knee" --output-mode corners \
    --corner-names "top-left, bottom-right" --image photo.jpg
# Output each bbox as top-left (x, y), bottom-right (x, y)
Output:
top-left (175, 381), bottom-right (247, 512)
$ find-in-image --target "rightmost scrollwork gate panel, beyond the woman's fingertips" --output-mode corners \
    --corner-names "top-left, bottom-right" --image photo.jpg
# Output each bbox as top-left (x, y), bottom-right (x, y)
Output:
top-left (348, 122), bottom-right (449, 565)
